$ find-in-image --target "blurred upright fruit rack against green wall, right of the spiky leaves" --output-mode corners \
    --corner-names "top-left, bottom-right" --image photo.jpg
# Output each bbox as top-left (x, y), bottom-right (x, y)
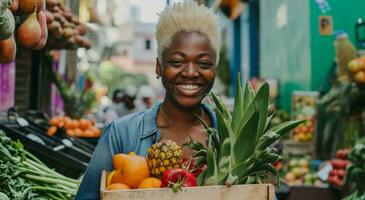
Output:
top-left (291, 91), bottom-right (318, 142)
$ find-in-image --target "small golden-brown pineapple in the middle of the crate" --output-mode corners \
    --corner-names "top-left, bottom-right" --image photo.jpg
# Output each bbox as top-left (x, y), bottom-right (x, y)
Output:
top-left (147, 140), bottom-right (182, 178)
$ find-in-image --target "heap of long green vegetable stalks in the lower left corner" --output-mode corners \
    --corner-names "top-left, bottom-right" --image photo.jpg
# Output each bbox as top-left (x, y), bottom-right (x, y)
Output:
top-left (0, 131), bottom-right (79, 200)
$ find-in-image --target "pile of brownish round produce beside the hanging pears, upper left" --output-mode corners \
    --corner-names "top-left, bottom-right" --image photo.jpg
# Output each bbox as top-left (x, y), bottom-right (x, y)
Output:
top-left (46, 0), bottom-right (91, 49)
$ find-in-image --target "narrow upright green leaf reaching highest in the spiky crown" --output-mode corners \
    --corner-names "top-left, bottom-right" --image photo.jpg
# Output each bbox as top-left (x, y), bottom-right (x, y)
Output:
top-left (232, 73), bottom-right (244, 131)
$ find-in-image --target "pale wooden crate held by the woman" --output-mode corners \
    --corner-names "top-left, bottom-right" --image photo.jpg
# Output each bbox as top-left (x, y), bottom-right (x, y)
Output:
top-left (100, 171), bottom-right (275, 200)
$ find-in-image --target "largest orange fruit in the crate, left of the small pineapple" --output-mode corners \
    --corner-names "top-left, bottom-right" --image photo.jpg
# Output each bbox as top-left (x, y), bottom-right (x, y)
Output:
top-left (111, 153), bottom-right (150, 188)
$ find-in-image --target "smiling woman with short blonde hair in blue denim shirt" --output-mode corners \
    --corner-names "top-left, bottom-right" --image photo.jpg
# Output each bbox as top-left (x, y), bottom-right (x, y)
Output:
top-left (76, 0), bottom-right (220, 199)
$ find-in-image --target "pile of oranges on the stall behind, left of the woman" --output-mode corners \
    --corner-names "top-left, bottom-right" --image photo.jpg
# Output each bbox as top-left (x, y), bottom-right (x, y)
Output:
top-left (47, 116), bottom-right (101, 138)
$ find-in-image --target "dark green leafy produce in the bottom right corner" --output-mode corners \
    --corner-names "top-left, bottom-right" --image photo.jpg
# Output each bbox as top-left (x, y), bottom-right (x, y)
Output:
top-left (344, 138), bottom-right (365, 200)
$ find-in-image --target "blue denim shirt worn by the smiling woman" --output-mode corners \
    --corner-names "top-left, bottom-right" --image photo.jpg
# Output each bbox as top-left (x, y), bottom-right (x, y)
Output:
top-left (75, 103), bottom-right (217, 200)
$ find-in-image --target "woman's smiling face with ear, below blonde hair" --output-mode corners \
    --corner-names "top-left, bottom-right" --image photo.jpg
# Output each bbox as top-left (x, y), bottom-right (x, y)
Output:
top-left (156, 32), bottom-right (216, 107)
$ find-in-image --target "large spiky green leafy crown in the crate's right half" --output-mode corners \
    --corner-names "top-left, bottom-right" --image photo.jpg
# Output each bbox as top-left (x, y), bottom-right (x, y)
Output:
top-left (188, 76), bottom-right (303, 185)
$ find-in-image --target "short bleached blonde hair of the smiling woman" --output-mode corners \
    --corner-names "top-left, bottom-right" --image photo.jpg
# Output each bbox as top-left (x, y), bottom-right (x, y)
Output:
top-left (156, 0), bottom-right (221, 64)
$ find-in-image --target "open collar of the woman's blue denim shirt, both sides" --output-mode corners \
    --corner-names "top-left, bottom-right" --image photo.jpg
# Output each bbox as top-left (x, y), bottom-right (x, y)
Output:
top-left (141, 103), bottom-right (218, 139)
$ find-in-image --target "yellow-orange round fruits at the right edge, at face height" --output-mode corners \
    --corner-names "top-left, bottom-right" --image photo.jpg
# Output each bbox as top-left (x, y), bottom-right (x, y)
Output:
top-left (347, 56), bottom-right (365, 85)
